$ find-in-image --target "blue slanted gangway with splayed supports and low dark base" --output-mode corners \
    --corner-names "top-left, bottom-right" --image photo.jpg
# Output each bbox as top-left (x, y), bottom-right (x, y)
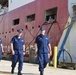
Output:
top-left (57, 21), bottom-right (76, 69)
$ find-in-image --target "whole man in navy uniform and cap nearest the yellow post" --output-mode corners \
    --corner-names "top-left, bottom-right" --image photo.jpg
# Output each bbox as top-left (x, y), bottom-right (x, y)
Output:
top-left (35, 27), bottom-right (52, 75)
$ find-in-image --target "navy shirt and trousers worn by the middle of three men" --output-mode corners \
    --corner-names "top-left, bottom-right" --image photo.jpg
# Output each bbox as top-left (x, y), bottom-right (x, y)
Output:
top-left (11, 35), bottom-right (25, 71)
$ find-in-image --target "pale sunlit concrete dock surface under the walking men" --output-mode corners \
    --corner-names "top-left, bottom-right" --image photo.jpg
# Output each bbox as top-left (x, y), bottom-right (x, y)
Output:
top-left (0, 60), bottom-right (76, 75)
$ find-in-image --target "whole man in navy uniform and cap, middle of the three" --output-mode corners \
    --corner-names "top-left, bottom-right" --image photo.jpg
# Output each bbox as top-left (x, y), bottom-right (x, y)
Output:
top-left (11, 29), bottom-right (25, 75)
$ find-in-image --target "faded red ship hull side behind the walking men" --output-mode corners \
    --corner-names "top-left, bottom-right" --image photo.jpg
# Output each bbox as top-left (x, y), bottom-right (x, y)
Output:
top-left (0, 0), bottom-right (69, 60)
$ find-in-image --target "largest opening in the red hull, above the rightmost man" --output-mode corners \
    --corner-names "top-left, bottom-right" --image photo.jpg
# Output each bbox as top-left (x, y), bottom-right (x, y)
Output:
top-left (44, 7), bottom-right (57, 22)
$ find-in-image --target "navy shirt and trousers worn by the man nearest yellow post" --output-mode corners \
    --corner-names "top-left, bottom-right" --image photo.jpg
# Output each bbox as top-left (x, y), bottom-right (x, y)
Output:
top-left (35, 34), bottom-right (50, 71)
